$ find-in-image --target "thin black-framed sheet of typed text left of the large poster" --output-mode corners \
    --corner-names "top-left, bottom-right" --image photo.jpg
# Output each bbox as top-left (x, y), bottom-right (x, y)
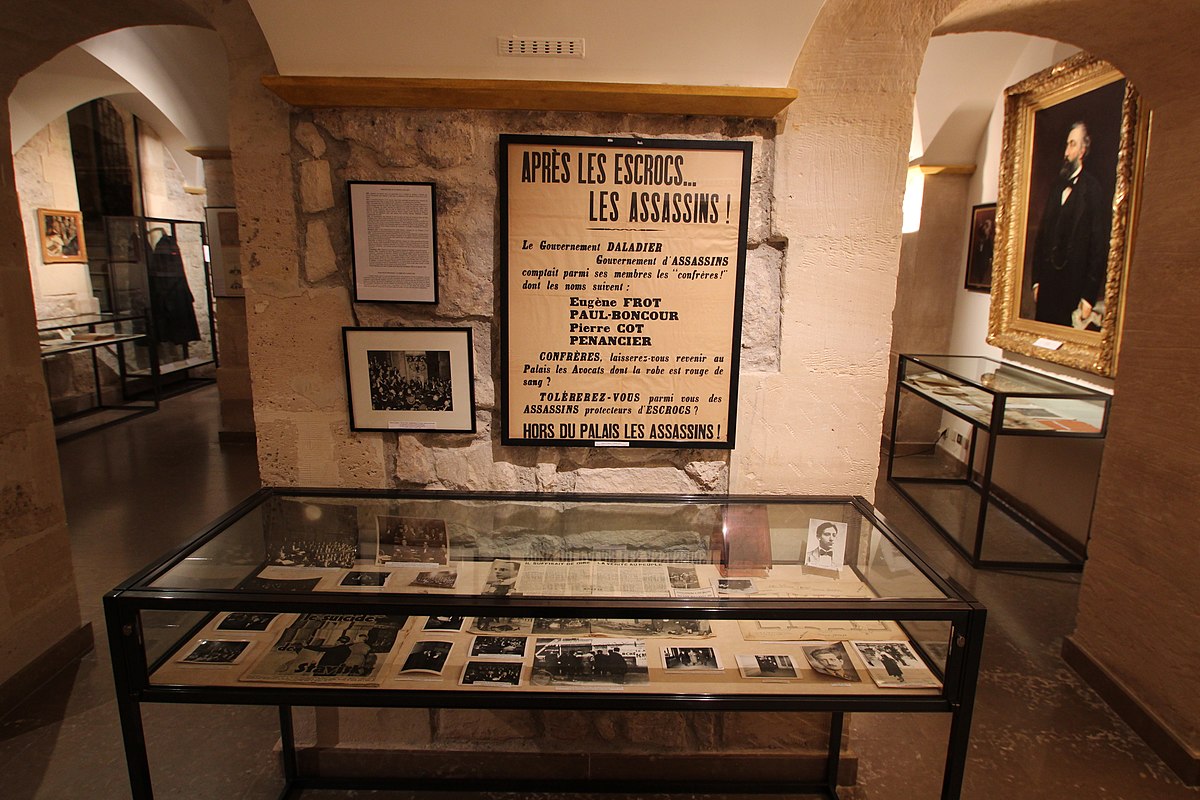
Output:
top-left (347, 181), bottom-right (438, 303)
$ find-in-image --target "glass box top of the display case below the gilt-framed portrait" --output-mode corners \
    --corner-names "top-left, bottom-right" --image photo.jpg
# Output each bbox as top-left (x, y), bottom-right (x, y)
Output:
top-left (900, 355), bottom-right (1111, 437)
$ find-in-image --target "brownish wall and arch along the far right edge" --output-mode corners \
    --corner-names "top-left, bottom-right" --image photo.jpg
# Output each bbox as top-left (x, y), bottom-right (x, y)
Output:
top-left (944, 0), bottom-right (1200, 758)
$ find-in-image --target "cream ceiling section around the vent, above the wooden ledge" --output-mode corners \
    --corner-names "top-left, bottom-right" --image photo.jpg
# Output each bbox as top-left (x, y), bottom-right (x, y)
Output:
top-left (250, 0), bottom-right (823, 86)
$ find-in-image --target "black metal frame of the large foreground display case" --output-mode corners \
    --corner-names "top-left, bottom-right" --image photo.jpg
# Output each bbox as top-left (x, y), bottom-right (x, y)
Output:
top-left (104, 488), bottom-right (986, 800)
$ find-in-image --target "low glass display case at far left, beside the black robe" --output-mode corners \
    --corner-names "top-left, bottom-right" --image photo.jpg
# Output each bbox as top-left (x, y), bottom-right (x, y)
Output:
top-left (37, 313), bottom-right (160, 441)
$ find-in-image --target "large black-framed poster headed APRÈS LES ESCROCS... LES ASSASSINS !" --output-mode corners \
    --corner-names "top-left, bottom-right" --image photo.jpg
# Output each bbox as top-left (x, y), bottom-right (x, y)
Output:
top-left (499, 136), bottom-right (751, 449)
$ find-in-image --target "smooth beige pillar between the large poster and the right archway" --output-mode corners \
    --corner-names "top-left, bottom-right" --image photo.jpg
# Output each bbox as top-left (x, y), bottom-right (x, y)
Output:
top-left (731, 0), bottom-right (948, 498)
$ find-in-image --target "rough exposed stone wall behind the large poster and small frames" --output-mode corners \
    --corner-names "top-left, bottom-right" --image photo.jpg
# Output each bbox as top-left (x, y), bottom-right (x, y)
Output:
top-left (253, 109), bottom-right (786, 493)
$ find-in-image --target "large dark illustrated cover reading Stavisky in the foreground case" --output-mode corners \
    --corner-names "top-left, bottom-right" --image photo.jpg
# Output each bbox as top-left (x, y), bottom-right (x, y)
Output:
top-left (241, 614), bottom-right (408, 685)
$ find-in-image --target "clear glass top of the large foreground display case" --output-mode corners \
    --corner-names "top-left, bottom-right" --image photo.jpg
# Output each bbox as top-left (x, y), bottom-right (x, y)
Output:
top-left (126, 492), bottom-right (950, 602)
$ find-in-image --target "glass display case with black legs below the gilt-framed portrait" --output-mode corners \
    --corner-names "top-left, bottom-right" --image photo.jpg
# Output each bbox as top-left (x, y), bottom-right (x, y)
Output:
top-left (888, 355), bottom-right (1111, 570)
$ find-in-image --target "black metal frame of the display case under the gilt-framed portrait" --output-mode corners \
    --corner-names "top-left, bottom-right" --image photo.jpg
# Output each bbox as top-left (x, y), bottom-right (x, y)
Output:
top-left (887, 354), bottom-right (1111, 572)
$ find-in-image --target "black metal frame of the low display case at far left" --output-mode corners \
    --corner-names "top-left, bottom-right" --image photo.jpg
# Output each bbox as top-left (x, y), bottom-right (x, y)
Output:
top-left (37, 313), bottom-right (162, 441)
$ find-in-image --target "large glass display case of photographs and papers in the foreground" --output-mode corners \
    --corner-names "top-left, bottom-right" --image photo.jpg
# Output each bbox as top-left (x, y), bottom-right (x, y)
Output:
top-left (104, 489), bottom-right (985, 799)
